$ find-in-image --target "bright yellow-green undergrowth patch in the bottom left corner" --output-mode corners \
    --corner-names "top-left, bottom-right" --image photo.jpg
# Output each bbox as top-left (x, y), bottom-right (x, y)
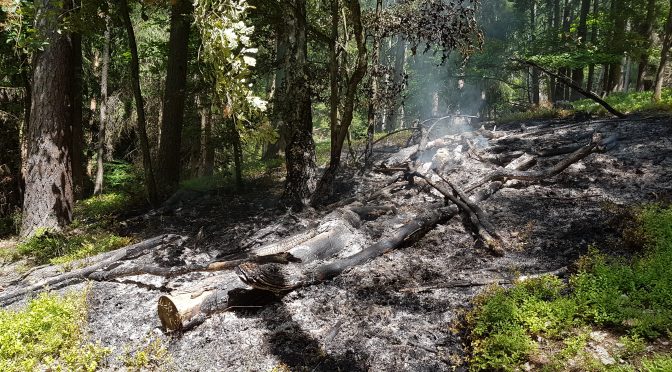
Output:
top-left (0, 292), bottom-right (109, 372)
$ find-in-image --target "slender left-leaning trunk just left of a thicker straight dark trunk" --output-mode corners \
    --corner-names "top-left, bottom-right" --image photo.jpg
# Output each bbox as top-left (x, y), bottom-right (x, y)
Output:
top-left (119, 0), bottom-right (159, 206)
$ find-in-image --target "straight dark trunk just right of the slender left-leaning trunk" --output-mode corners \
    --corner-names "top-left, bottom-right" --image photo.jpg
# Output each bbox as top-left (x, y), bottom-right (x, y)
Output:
top-left (158, 0), bottom-right (193, 199)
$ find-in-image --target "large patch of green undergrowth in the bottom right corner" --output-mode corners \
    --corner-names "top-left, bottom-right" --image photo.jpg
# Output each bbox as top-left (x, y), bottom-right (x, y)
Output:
top-left (466, 206), bottom-right (672, 371)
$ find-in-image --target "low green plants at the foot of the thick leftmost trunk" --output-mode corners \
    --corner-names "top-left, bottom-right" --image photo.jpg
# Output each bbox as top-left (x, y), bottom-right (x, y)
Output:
top-left (9, 229), bottom-right (131, 265)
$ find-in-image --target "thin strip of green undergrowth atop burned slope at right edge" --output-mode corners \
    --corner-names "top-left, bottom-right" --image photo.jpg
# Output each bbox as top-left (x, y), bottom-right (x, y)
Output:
top-left (572, 88), bottom-right (672, 115)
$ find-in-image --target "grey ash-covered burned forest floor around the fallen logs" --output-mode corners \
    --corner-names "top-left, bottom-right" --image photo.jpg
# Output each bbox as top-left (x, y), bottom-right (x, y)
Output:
top-left (0, 113), bottom-right (672, 371)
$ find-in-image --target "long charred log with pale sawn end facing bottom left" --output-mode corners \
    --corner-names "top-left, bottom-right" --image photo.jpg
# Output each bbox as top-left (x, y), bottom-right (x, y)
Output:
top-left (157, 154), bottom-right (535, 331)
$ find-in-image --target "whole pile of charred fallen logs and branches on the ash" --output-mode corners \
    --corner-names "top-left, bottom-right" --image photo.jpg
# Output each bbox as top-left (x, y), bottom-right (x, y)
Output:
top-left (0, 123), bottom-right (618, 331)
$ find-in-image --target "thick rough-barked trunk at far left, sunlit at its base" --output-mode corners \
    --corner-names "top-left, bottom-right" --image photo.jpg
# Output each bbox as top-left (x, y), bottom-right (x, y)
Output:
top-left (21, 0), bottom-right (75, 236)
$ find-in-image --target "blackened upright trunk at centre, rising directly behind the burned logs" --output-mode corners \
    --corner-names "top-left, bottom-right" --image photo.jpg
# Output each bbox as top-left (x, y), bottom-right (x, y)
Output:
top-left (280, 0), bottom-right (317, 209)
